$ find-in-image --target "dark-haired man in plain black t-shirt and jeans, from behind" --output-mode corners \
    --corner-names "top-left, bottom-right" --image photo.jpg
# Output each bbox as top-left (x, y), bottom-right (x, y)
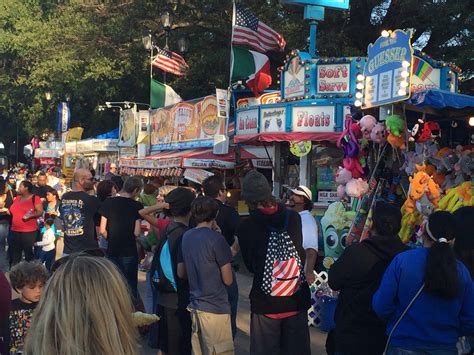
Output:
top-left (99, 176), bottom-right (143, 300)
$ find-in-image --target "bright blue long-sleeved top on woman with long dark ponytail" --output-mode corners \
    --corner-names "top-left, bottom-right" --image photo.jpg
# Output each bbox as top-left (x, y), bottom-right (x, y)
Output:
top-left (372, 248), bottom-right (474, 350)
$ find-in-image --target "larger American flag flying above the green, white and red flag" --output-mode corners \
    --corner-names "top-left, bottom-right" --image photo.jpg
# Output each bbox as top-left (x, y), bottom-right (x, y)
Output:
top-left (232, 5), bottom-right (286, 53)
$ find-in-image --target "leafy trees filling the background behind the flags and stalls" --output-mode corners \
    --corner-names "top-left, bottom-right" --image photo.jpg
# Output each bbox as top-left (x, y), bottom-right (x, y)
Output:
top-left (0, 0), bottom-right (474, 150)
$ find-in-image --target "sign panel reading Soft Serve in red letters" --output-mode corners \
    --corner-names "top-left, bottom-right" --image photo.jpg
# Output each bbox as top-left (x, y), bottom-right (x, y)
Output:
top-left (317, 64), bottom-right (350, 93)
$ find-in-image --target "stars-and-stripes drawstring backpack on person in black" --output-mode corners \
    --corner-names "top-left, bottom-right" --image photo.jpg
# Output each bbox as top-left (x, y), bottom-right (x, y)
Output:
top-left (261, 211), bottom-right (304, 297)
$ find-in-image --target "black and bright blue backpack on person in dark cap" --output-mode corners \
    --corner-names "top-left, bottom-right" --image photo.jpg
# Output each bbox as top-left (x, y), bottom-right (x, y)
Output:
top-left (150, 223), bottom-right (187, 293)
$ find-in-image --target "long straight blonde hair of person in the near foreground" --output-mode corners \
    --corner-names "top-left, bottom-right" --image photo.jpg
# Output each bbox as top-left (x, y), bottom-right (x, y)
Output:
top-left (25, 254), bottom-right (138, 355)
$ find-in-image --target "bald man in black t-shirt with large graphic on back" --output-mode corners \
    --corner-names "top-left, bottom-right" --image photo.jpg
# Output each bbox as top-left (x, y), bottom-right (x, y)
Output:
top-left (59, 169), bottom-right (99, 255)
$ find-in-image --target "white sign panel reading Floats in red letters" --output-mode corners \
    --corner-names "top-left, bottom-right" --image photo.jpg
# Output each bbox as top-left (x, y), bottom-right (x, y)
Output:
top-left (292, 106), bottom-right (336, 132)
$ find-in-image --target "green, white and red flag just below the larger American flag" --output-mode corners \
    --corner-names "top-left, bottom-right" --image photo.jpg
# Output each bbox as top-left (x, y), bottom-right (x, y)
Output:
top-left (231, 47), bottom-right (272, 96)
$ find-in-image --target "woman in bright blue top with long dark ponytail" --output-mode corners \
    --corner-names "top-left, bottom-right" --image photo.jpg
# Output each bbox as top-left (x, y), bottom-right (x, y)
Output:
top-left (372, 211), bottom-right (474, 355)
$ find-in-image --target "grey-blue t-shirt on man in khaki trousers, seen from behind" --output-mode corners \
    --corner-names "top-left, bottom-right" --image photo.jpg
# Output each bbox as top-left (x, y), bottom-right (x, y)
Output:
top-left (178, 228), bottom-right (232, 314)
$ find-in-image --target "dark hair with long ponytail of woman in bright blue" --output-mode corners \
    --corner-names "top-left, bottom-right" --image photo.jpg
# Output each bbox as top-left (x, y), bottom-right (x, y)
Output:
top-left (425, 211), bottom-right (459, 299)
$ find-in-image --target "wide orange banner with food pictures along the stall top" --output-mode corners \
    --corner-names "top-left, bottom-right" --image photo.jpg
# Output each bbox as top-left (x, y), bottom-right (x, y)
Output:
top-left (150, 96), bottom-right (226, 150)
